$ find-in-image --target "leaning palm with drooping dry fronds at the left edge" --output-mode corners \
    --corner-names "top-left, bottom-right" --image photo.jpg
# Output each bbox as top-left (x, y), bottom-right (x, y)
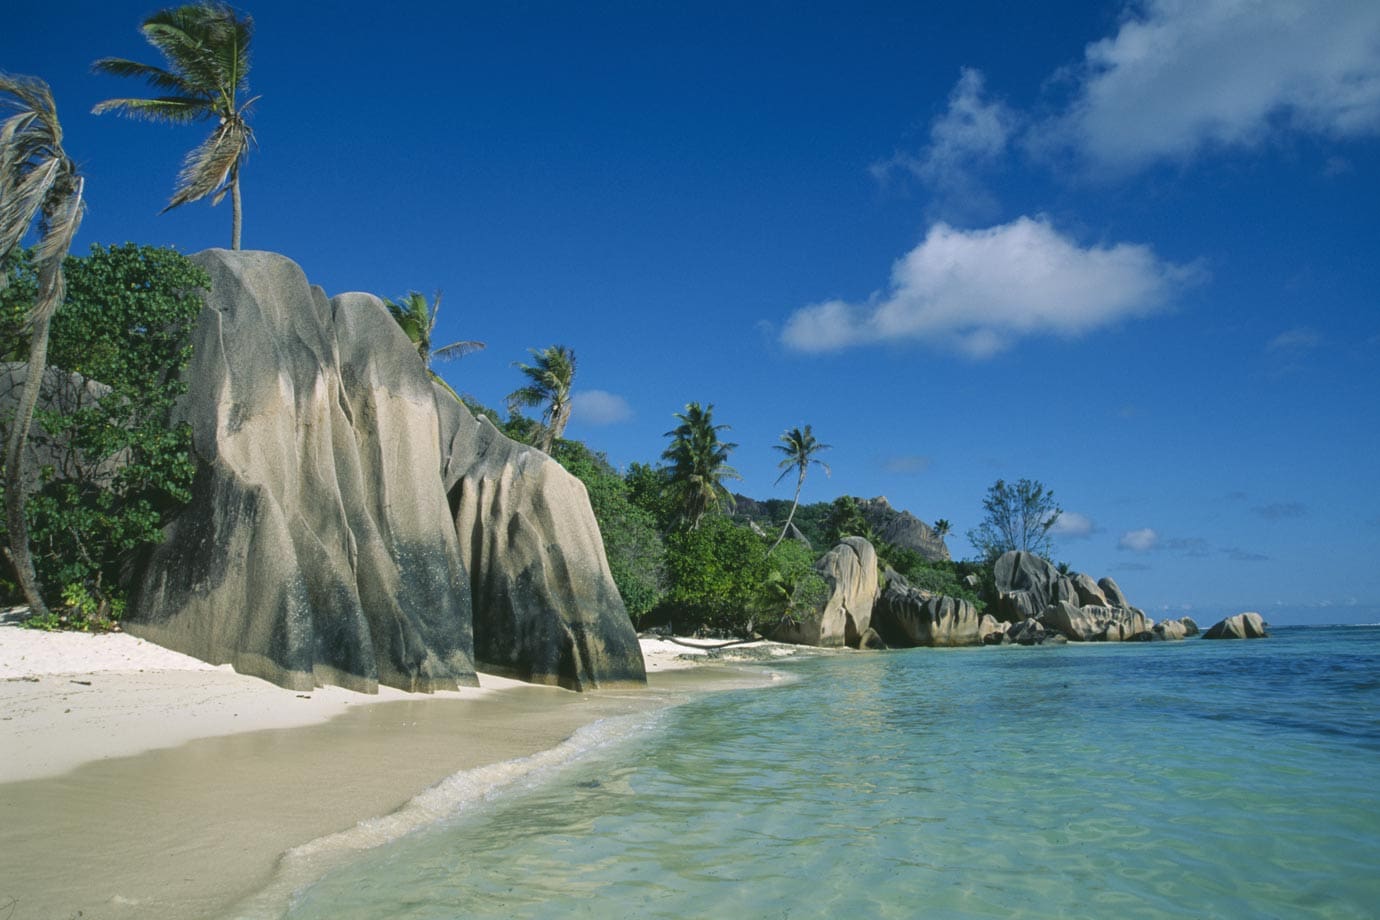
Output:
top-left (0, 73), bottom-right (84, 617)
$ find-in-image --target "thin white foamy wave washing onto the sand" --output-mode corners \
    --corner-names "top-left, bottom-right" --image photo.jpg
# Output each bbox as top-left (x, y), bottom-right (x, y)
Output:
top-left (226, 712), bottom-right (661, 920)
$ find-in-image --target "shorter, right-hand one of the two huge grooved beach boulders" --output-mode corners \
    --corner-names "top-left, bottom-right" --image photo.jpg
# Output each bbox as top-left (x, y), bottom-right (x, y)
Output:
top-left (435, 397), bottom-right (645, 690)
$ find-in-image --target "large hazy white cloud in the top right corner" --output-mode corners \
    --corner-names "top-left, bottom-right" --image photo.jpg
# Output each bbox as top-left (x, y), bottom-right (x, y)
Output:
top-left (1031, 0), bottom-right (1380, 172)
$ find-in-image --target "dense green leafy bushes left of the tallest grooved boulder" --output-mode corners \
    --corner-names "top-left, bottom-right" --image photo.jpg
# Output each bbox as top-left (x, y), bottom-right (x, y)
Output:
top-left (0, 244), bottom-right (210, 626)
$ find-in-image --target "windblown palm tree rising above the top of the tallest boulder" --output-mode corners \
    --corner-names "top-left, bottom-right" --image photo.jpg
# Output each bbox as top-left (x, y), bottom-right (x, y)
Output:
top-left (91, 0), bottom-right (258, 250)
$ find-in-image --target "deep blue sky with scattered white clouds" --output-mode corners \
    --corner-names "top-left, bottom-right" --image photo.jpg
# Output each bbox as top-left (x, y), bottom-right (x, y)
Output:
top-left (0, 0), bottom-right (1380, 623)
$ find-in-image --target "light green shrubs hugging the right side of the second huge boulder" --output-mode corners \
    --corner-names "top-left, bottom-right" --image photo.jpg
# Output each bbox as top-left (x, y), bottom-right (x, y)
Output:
top-left (553, 440), bottom-right (667, 623)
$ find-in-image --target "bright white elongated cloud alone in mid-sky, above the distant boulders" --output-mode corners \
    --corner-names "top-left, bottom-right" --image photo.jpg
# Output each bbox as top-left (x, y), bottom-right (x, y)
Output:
top-left (781, 217), bottom-right (1202, 357)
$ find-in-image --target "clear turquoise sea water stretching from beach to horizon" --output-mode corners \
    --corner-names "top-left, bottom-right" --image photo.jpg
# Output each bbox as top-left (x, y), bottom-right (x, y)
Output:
top-left (274, 628), bottom-right (1380, 920)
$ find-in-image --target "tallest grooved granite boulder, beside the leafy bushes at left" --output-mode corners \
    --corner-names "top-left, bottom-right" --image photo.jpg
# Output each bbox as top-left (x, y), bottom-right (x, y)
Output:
top-left (126, 250), bottom-right (477, 692)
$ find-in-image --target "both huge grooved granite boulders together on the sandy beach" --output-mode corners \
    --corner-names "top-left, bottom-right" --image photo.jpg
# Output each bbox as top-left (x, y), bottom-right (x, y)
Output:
top-left (126, 250), bottom-right (646, 691)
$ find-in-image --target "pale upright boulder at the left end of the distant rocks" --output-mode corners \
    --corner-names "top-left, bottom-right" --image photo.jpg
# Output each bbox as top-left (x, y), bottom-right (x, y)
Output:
top-left (771, 537), bottom-right (878, 648)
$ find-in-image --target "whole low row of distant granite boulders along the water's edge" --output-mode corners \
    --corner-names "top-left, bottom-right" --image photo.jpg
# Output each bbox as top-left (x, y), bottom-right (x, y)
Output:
top-left (773, 538), bottom-right (1267, 648)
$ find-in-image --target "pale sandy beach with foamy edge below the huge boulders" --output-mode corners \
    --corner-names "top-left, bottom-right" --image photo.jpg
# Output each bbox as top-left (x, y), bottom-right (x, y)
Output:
top-left (0, 623), bottom-right (791, 920)
